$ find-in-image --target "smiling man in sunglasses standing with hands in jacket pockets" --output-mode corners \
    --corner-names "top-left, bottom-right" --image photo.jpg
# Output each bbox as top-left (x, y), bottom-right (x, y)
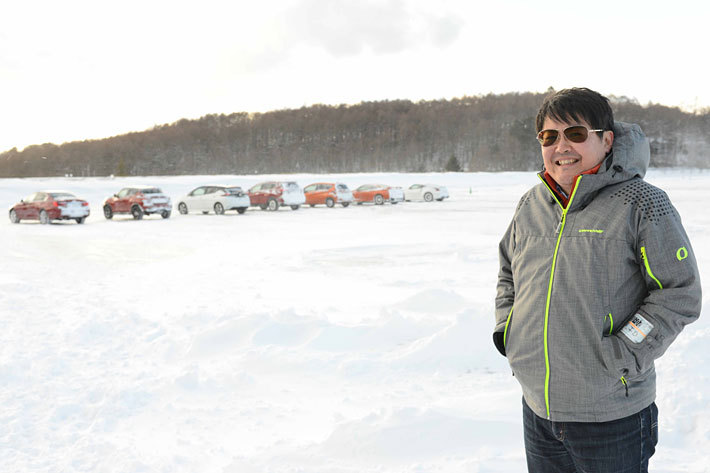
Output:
top-left (493, 88), bottom-right (701, 473)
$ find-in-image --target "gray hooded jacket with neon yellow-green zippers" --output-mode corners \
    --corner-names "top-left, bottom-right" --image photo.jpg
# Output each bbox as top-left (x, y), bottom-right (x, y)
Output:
top-left (493, 123), bottom-right (701, 422)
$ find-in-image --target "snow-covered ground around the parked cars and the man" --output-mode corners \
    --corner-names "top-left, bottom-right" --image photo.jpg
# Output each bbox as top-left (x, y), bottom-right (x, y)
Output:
top-left (0, 170), bottom-right (710, 473)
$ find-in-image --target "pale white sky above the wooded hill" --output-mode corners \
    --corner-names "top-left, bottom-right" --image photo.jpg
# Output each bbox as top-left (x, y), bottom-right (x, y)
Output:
top-left (0, 0), bottom-right (710, 151)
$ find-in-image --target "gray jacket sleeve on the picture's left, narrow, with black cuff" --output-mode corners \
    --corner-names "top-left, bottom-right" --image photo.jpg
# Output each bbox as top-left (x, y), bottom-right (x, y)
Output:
top-left (493, 214), bottom-right (515, 356)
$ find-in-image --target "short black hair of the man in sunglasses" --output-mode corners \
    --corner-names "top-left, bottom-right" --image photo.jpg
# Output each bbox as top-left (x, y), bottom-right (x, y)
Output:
top-left (535, 87), bottom-right (614, 132)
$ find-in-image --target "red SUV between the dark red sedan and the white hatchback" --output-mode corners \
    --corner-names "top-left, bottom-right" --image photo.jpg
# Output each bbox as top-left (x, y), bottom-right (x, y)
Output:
top-left (104, 186), bottom-right (172, 220)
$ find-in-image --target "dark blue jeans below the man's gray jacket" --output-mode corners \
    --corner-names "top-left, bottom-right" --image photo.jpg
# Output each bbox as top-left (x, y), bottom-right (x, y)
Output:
top-left (523, 400), bottom-right (658, 473)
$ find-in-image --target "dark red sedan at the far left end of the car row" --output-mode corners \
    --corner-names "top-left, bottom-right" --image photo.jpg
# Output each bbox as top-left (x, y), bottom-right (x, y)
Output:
top-left (10, 191), bottom-right (90, 224)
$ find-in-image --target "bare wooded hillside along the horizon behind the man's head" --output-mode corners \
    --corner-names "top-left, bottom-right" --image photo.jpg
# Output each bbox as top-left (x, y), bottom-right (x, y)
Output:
top-left (0, 93), bottom-right (710, 177)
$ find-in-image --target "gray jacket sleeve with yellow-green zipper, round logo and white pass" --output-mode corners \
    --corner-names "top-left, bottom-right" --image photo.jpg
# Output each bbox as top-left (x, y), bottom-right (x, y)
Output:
top-left (613, 190), bottom-right (701, 376)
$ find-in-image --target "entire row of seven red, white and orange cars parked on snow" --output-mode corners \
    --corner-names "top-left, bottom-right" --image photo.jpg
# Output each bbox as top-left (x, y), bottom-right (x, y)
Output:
top-left (9, 181), bottom-right (449, 224)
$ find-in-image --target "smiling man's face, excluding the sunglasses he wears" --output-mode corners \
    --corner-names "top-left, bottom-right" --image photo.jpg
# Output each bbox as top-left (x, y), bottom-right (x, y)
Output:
top-left (541, 117), bottom-right (614, 194)
